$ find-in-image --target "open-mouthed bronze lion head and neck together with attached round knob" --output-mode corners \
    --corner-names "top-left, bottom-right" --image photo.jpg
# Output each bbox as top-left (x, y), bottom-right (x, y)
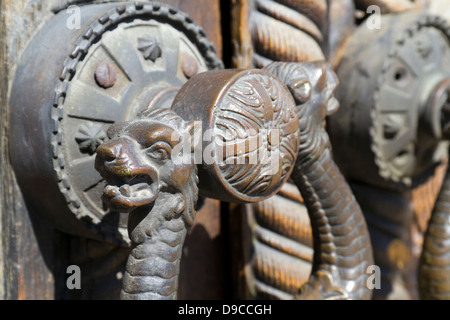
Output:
top-left (96, 70), bottom-right (300, 299)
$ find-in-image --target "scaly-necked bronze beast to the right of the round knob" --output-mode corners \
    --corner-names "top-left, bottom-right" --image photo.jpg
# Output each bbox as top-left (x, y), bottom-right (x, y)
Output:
top-left (266, 62), bottom-right (373, 299)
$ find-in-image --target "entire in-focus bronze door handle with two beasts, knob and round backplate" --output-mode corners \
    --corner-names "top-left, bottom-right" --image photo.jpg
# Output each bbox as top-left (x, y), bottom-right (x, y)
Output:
top-left (10, 2), bottom-right (372, 299)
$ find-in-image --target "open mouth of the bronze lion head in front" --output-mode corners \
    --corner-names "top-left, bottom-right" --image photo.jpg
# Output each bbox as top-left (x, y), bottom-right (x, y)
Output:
top-left (103, 175), bottom-right (158, 212)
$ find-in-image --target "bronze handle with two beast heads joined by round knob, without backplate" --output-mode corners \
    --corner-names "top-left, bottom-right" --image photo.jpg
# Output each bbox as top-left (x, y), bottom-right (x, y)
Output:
top-left (96, 62), bottom-right (373, 299)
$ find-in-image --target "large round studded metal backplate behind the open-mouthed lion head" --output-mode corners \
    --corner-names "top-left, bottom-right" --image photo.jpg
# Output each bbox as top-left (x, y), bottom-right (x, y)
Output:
top-left (10, 2), bottom-right (222, 244)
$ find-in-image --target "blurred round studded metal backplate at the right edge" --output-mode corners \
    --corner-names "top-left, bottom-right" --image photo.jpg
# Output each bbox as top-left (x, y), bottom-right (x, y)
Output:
top-left (329, 13), bottom-right (450, 189)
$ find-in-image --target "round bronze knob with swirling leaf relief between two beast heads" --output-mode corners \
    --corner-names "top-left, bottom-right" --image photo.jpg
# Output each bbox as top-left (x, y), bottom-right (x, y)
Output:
top-left (172, 69), bottom-right (300, 203)
